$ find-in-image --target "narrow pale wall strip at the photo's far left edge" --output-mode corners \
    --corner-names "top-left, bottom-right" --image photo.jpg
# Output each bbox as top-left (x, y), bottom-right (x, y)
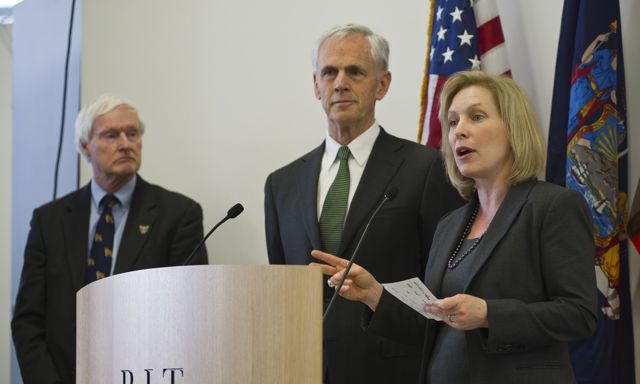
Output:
top-left (0, 25), bottom-right (13, 383)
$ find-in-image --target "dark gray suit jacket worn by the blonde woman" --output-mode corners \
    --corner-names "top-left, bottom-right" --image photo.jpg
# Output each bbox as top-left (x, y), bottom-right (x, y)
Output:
top-left (365, 180), bottom-right (597, 384)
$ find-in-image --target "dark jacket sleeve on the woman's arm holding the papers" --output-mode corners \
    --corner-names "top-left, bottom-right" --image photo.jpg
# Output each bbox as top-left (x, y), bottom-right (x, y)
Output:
top-left (486, 191), bottom-right (597, 352)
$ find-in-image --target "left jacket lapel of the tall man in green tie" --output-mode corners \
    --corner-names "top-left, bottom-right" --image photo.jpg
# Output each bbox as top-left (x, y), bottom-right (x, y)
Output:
top-left (296, 142), bottom-right (324, 249)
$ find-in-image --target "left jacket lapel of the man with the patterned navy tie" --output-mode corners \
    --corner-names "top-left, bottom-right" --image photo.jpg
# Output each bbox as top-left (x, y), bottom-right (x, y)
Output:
top-left (62, 184), bottom-right (91, 291)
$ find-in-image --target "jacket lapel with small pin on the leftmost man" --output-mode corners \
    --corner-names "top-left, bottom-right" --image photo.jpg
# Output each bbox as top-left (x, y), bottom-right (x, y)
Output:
top-left (114, 176), bottom-right (158, 273)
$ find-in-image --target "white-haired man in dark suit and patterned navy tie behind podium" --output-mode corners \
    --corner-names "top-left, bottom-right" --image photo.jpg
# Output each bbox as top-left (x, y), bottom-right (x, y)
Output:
top-left (11, 95), bottom-right (207, 384)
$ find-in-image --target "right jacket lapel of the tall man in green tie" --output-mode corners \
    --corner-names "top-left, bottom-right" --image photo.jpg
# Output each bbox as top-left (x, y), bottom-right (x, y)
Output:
top-left (338, 128), bottom-right (404, 256)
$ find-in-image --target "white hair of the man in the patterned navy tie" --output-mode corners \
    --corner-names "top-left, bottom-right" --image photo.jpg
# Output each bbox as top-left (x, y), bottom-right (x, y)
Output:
top-left (74, 93), bottom-right (144, 160)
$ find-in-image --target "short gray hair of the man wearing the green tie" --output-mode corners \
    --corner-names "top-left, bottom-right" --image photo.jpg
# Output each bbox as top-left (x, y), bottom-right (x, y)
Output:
top-left (311, 24), bottom-right (389, 74)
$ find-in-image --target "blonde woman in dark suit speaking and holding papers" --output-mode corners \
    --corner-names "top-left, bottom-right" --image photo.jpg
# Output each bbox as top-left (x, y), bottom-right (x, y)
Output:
top-left (312, 72), bottom-right (596, 384)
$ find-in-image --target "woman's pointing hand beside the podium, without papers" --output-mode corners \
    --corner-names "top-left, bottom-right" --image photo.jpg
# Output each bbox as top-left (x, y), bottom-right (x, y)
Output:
top-left (309, 250), bottom-right (384, 311)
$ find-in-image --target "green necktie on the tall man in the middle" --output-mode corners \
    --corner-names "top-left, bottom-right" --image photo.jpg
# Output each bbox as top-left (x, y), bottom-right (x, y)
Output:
top-left (319, 146), bottom-right (350, 255)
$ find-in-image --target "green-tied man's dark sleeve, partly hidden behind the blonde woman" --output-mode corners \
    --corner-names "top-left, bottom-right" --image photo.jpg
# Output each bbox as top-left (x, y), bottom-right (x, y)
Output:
top-left (420, 155), bottom-right (465, 279)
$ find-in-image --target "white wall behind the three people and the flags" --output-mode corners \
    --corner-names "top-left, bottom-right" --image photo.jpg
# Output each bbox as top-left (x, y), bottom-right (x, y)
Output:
top-left (82, 0), bottom-right (640, 382)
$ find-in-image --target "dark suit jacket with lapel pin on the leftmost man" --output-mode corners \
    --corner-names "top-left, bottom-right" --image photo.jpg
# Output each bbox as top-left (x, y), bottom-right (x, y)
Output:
top-left (11, 176), bottom-right (207, 384)
